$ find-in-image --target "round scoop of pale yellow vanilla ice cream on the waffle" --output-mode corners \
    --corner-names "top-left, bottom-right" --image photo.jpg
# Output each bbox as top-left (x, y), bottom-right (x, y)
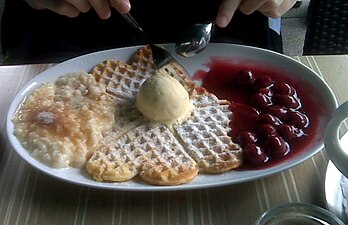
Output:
top-left (136, 73), bottom-right (192, 122)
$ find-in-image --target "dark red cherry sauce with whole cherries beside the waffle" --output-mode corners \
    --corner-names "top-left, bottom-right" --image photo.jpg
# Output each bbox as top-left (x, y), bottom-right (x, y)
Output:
top-left (193, 57), bottom-right (323, 170)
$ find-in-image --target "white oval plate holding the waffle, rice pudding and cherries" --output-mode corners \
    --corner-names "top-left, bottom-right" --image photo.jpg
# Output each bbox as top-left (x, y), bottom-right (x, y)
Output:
top-left (6, 44), bottom-right (337, 191)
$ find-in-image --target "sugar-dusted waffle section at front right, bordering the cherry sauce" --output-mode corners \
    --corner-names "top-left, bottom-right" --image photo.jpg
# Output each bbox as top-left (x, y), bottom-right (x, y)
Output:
top-left (174, 105), bottom-right (242, 173)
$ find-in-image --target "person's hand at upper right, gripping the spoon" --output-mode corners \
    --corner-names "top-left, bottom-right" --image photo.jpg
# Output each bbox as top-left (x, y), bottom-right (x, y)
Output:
top-left (215, 0), bottom-right (296, 27)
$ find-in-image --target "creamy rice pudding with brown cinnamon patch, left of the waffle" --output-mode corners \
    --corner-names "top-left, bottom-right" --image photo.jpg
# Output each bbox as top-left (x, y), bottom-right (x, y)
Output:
top-left (13, 72), bottom-right (115, 168)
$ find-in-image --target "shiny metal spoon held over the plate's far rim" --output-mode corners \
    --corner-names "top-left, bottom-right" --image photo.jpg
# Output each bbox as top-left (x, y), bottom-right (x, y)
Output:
top-left (175, 22), bottom-right (214, 57)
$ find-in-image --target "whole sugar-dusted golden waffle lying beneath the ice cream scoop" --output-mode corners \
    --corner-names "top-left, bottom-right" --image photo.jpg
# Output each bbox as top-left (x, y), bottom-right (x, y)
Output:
top-left (86, 46), bottom-right (242, 185)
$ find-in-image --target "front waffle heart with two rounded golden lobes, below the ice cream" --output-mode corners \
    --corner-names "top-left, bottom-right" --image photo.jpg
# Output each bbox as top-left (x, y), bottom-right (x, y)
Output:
top-left (86, 125), bottom-right (198, 185)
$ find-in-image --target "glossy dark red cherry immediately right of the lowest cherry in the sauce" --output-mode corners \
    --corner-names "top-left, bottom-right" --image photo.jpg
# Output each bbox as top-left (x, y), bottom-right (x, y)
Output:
top-left (265, 135), bottom-right (290, 158)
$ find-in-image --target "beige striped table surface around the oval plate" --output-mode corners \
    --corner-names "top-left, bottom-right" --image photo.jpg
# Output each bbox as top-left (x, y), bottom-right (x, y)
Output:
top-left (0, 55), bottom-right (348, 225)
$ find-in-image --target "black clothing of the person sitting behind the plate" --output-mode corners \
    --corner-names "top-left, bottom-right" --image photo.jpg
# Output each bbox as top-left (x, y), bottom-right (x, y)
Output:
top-left (1, 0), bottom-right (282, 64)
